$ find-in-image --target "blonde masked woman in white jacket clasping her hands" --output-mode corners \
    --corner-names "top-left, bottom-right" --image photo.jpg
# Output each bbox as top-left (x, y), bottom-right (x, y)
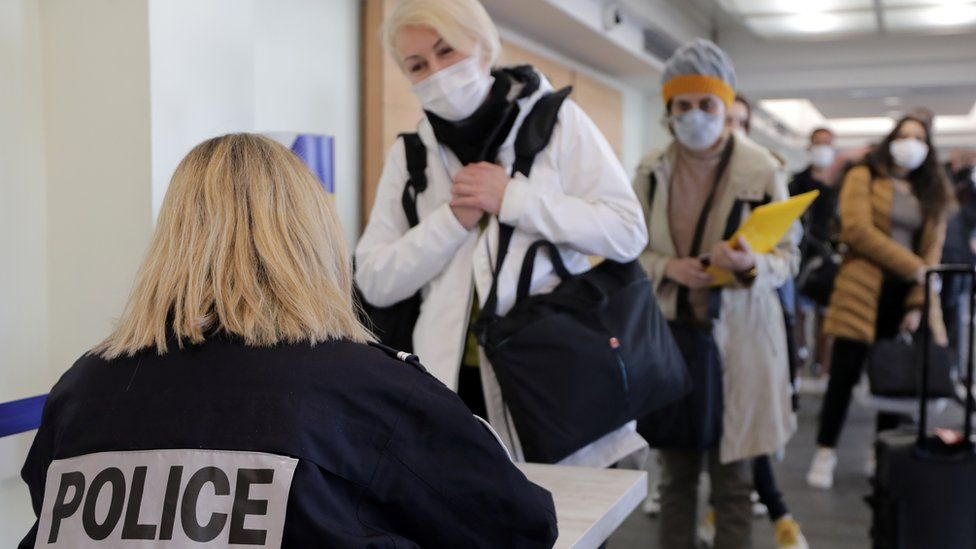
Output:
top-left (356, 0), bottom-right (647, 467)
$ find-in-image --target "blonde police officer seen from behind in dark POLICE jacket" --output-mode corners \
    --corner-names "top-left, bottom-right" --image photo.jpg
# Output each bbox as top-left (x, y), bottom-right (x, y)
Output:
top-left (20, 134), bottom-right (556, 547)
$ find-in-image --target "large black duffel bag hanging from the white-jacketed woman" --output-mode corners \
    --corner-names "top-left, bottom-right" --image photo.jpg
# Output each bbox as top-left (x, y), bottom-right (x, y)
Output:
top-left (475, 239), bottom-right (691, 463)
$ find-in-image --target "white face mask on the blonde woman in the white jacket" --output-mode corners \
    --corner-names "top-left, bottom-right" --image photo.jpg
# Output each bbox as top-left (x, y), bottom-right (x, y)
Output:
top-left (410, 55), bottom-right (495, 122)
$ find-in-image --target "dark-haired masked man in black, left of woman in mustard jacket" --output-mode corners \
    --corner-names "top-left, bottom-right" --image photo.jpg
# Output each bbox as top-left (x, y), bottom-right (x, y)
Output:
top-left (790, 127), bottom-right (837, 373)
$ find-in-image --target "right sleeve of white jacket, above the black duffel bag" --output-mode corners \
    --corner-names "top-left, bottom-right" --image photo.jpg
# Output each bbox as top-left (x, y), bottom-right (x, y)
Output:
top-left (498, 100), bottom-right (647, 261)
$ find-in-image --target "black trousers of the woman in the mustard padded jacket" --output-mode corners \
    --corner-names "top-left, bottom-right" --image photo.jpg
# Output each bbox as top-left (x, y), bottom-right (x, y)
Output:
top-left (817, 279), bottom-right (913, 448)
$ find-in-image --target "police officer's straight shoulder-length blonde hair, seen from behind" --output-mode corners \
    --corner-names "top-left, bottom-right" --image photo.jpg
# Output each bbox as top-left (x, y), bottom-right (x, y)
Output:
top-left (92, 133), bottom-right (372, 359)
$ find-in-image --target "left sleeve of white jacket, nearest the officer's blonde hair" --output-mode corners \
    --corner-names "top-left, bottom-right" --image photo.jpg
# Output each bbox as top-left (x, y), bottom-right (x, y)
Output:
top-left (356, 139), bottom-right (468, 307)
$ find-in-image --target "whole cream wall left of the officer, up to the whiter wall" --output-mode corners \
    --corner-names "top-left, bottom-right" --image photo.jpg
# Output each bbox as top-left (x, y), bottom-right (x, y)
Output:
top-left (0, 0), bottom-right (151, 547)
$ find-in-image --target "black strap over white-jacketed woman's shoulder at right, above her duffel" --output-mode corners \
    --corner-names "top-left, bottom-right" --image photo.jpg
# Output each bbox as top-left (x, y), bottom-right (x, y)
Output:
top-left (478, 86), bottom-right (573, 324)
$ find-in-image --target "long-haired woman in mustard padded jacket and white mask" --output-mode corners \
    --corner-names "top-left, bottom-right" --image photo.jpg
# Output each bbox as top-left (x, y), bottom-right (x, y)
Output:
top-left (807, 116), bottom-right (955, 489)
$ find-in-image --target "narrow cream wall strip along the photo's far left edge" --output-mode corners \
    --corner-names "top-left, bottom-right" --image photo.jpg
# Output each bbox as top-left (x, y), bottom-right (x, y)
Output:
top-left (0, 0), bottom-right (51, 547)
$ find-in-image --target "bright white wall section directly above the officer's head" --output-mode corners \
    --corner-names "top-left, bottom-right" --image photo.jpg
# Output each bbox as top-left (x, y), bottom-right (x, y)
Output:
top-left (149, 0), bottom-right (360, 242)
